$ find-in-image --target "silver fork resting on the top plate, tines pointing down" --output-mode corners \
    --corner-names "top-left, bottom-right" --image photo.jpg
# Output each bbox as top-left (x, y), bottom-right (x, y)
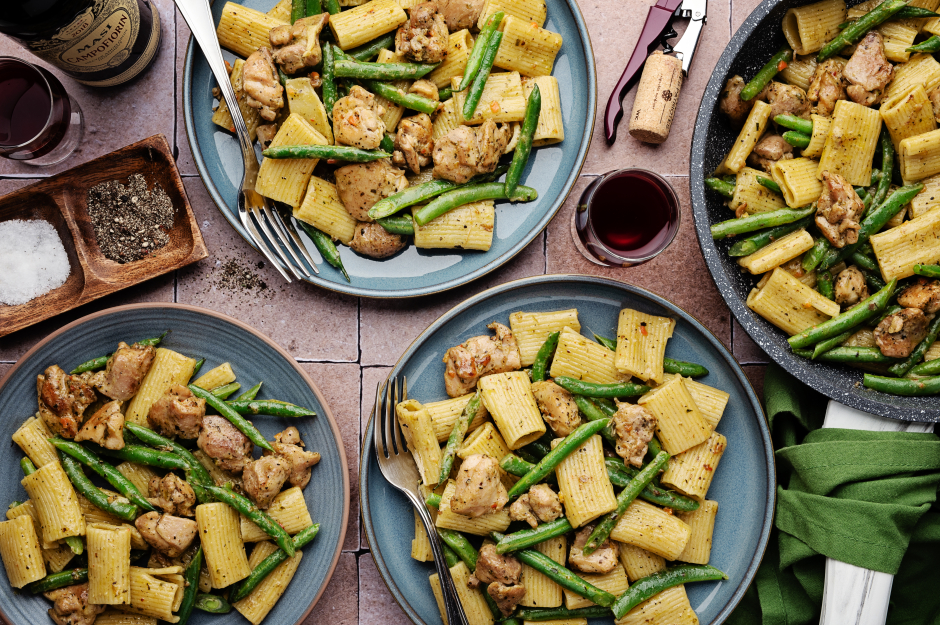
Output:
top-left (175, 0), bottom-right (320, 282)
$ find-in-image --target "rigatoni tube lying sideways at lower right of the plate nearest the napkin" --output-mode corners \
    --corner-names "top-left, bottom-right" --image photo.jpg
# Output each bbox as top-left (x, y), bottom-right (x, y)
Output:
top-left (610, 499), bottom-right (691, 560)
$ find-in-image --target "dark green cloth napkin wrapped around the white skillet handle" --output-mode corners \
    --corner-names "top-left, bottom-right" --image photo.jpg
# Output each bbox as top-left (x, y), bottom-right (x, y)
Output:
top-left (727, 365), bottom-right (940, 625)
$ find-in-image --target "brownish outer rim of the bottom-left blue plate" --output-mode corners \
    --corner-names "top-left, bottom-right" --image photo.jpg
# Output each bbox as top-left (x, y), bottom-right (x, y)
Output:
top-left (0, 302), bottom-right (350, 625)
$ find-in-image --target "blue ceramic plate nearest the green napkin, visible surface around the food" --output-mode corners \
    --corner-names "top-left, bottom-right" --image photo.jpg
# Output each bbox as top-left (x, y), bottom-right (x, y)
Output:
top-left (360, 276), bottom-right (775, 625)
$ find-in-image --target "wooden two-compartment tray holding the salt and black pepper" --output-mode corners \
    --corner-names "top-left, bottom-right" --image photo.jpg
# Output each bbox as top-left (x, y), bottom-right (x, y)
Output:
top-left (0, 135), bottom-right (209, 336)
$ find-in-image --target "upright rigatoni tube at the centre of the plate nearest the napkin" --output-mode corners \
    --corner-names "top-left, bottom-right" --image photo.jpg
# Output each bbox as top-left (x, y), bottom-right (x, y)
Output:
top-left (552, 434), bottom-right (617, 528)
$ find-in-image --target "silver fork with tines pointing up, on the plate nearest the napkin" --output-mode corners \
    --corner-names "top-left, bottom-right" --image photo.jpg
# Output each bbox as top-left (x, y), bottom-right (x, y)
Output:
top-left (372, 378), bottom-right (468, 625)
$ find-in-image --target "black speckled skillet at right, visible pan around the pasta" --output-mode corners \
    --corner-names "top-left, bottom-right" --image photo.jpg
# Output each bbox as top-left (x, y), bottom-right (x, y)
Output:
top-left (689, 0), bottom-right (940, 422)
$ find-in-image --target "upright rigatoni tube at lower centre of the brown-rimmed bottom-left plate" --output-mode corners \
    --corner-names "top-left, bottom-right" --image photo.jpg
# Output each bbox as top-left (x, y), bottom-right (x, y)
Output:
top-left (196, 502), bottom-right (251, 588)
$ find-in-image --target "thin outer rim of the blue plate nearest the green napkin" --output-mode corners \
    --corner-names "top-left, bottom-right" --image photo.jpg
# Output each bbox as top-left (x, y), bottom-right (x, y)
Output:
top-left (359, 273), bottom-right (777, 625)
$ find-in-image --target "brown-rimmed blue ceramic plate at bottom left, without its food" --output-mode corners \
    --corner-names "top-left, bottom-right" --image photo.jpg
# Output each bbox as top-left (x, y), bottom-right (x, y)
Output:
top-left (0, 304), bottom-right (349, 625)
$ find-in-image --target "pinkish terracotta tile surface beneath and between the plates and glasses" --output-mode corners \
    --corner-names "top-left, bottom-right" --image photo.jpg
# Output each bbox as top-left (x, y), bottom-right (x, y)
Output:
top-left (0, 0), bottom-right (767, 625)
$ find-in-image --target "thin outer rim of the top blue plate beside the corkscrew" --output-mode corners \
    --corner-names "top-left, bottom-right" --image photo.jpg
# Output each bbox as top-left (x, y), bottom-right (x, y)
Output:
top-left (183, 0), bottom-right (597, 299)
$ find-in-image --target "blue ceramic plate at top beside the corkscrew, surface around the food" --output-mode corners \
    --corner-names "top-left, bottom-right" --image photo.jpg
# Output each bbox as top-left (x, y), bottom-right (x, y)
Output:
top-left (183, 0), bottom-right (597, 298)
